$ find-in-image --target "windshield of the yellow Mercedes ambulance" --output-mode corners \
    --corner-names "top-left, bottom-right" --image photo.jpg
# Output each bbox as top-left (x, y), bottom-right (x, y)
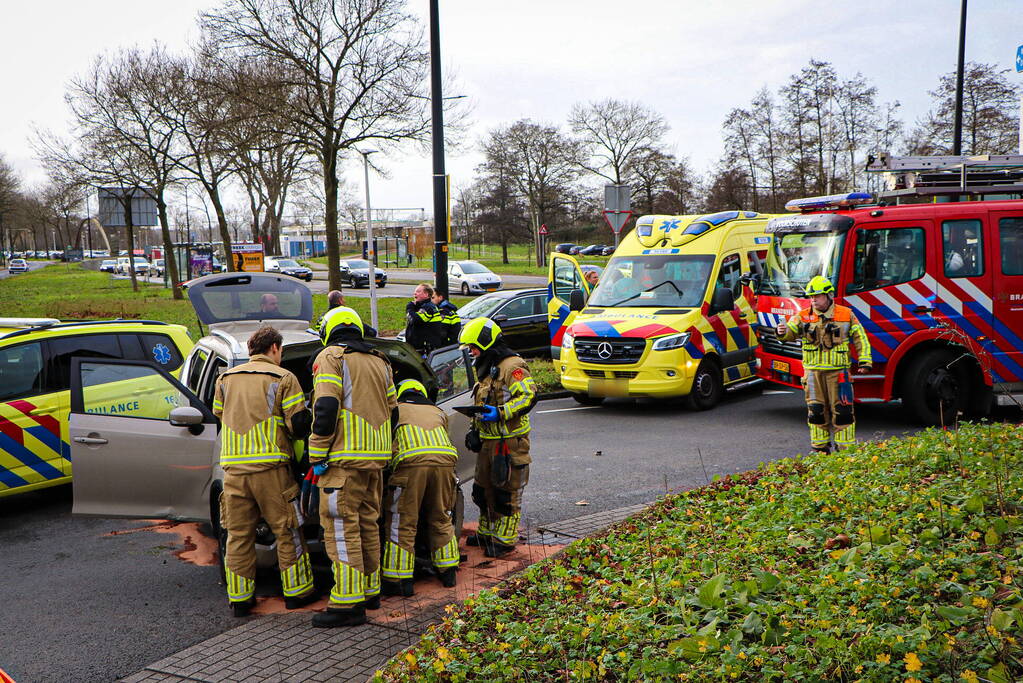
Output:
top-left (587, 254), bottom-right (714, 308)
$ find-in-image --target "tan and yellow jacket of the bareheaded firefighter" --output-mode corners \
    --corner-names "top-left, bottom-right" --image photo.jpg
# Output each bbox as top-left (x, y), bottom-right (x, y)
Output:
top-left (213, 354), bottom-right (310, 474)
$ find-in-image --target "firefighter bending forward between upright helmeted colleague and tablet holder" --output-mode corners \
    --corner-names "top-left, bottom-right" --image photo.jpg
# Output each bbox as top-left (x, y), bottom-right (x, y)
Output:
top-left (382, 379), bottom-right (458, 597)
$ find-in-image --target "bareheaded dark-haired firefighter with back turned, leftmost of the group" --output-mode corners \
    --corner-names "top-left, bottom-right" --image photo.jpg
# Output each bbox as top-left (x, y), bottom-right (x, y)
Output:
top-left (213, 325), bottom-right (316, 617)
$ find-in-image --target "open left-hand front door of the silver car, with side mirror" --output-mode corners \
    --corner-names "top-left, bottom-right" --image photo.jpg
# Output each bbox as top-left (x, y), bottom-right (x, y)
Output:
top-left (69, 358), bottom-right (219, 521)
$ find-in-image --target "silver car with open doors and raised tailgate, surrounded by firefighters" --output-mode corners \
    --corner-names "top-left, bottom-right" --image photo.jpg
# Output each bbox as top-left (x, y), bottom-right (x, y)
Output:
top-left (69, 273), bottom-right (476, 566)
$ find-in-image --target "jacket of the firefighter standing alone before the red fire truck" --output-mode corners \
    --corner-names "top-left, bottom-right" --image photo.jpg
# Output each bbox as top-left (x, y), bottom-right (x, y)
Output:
top-left (781, 304), bottom-right (871, 370)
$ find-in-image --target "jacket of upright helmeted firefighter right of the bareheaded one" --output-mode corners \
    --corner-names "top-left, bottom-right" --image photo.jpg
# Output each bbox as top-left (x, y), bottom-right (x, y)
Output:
top-left (309, 346), bottom-right (398, 472)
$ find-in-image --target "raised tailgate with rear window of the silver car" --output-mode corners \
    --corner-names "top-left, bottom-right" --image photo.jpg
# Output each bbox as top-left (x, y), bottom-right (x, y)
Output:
top-left (188, 273), bottom-right (313, 328)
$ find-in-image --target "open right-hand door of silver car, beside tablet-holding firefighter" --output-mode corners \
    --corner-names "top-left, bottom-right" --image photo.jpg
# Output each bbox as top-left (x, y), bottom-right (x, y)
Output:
top-left (427, 346), bottom-right (476, 483)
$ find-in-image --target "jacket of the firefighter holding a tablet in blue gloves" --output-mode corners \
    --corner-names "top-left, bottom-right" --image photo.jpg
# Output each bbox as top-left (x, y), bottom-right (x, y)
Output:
top-left (473, 355), bottom-right (536, 439)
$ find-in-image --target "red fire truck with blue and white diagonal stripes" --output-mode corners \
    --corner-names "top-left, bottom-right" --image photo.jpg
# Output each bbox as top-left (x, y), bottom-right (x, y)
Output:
top-left (756, 155), bottom-right (1023, 424)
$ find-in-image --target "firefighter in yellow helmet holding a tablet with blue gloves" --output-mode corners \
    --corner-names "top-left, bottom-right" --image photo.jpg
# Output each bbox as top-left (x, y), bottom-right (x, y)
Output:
top-left (458, 318), bottom-right (536, 557)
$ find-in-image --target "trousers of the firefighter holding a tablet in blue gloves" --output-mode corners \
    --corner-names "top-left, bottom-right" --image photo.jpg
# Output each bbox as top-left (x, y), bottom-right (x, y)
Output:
top-left (473, 437), bottom-right (530, 545)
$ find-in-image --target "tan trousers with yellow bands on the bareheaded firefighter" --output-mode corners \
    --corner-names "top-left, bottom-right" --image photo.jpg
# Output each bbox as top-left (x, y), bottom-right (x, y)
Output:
top-left (220, 464), bottom-right (313, 602)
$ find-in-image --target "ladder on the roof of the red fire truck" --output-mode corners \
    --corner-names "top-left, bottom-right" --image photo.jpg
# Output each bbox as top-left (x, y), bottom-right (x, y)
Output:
top-left (866, 153), bottom-right (1023, 200)
